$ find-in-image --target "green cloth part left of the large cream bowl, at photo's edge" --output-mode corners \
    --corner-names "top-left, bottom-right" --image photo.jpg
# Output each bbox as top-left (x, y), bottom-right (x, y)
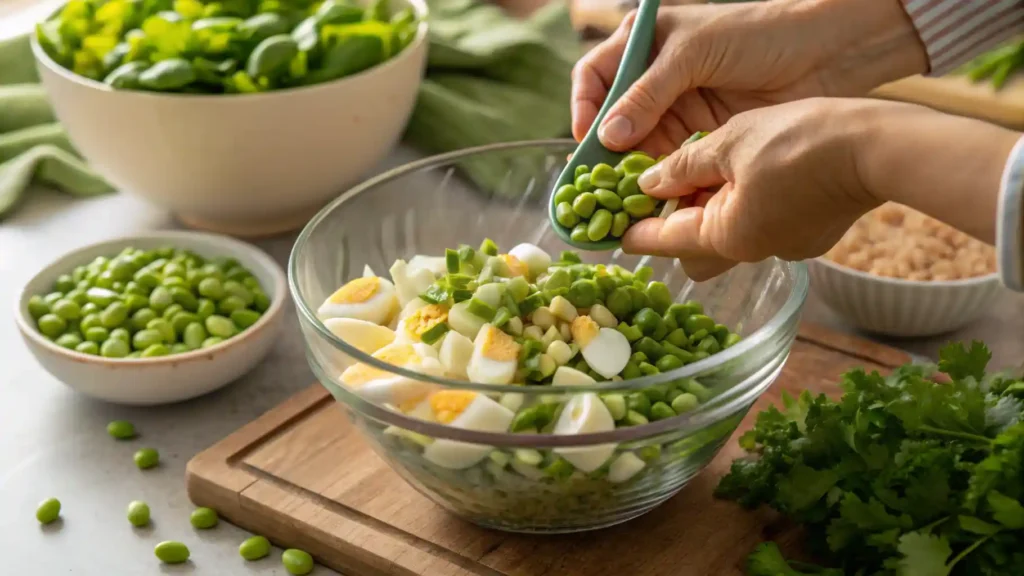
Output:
top-left (0, 35), bottom-right (114, 220)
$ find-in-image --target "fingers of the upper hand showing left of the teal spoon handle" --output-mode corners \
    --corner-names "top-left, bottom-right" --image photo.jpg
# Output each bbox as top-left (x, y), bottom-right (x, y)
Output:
top-left (570, 13), bottom-right (636, 141)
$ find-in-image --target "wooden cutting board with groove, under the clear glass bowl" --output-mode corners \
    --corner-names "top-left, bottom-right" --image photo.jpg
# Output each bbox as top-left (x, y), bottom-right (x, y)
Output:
top-left (186, 325), bottom-right (909, 576)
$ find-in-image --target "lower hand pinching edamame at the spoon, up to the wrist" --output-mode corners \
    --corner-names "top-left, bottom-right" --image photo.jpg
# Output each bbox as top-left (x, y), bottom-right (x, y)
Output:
top-left (623, 98), bottom-right (886, 281)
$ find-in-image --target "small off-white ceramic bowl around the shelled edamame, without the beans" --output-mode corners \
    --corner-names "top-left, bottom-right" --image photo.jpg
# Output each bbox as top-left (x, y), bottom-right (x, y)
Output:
top-left (14, 232), bottom-right (288, 406)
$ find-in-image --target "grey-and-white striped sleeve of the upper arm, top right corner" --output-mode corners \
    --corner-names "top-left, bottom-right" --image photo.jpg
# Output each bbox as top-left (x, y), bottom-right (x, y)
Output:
top-left (901, 0), bottom-right (1024, 76)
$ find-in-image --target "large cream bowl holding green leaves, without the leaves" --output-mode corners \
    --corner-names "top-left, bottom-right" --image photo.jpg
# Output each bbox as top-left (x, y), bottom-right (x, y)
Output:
top-left (32, 0), bottom-right (427, 237)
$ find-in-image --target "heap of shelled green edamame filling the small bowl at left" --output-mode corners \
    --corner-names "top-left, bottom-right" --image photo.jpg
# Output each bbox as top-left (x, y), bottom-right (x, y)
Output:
top-left (29, 247), bottom-right (270, 356)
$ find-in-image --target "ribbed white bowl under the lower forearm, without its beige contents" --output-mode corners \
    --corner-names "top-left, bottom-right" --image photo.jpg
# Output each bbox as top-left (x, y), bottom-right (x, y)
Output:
top-left (808, 257), bottom-right (1001, 337)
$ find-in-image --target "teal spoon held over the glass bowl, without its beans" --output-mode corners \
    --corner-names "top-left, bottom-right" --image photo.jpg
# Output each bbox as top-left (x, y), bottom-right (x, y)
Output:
top-left (548, 0), bottom-right (662, 251)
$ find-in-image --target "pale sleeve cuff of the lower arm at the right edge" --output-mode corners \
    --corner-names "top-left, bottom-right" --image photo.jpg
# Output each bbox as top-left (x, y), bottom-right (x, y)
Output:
top-left (995, 136), bottom-right (1024, 292)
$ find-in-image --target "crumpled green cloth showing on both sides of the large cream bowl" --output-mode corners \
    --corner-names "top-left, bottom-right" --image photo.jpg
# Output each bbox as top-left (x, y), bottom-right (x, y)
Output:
top-left (0, 0), bottom-right (581, 216)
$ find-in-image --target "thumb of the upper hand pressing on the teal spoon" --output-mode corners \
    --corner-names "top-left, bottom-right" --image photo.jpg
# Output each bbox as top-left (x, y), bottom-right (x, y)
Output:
top-left (598, 33), bottom-right (694, 151)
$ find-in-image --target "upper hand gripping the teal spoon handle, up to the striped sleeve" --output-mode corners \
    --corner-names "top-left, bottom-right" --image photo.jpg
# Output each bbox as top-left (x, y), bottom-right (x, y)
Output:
top-left (571, 0), bottom-right (928, 156)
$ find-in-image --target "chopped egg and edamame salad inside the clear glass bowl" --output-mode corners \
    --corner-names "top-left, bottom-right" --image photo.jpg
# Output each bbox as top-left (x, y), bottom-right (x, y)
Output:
top-left (317, 240), bottom-right (739, 483)
